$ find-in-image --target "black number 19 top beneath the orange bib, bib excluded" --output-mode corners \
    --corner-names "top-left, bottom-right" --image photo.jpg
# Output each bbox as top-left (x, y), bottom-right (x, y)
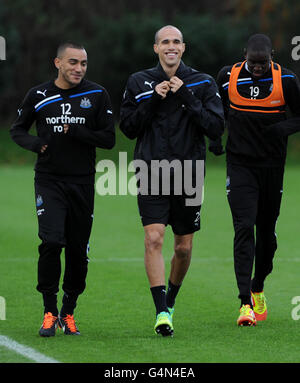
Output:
top-left (217, 65), bottom-right (300, 167)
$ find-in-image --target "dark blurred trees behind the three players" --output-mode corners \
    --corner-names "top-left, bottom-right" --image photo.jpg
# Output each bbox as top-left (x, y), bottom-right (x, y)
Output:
top-left (0, 0), bottom-right (300, 127)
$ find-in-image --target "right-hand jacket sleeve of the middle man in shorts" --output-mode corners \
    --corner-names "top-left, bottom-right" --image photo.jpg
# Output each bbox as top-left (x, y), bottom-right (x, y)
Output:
top-left (177, 77), bottom-right (224, 140)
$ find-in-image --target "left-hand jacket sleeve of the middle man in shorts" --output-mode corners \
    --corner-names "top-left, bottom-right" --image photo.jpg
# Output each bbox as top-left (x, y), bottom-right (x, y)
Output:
top-left (120, 76), bottom-right (161, 139)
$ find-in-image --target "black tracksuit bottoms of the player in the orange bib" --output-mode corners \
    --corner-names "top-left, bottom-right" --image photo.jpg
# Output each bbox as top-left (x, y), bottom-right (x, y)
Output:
top-left (226, 163), bottom-right (284, 304)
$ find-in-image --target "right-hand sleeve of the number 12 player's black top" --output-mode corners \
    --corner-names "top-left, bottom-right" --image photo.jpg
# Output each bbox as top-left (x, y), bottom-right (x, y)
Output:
top-left (69, 89), bottom-right (115, 149)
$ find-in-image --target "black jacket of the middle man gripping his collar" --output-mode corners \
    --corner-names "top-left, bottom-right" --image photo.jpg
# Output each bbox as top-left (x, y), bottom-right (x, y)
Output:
top-left (120, 62), bottom-right (224, 163)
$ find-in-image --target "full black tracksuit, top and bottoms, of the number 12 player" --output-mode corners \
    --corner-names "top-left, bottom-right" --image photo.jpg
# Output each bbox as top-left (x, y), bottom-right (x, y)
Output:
top-left (10, 79), bottom-right (115, 318)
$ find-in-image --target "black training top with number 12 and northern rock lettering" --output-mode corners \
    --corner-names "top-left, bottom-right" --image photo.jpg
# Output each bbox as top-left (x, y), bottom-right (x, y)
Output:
top-left (10, 79), bottom-right (115, 184)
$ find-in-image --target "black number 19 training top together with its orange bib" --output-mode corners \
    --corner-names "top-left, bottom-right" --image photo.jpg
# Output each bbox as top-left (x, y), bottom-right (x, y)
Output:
top-left (216, 62), bottom-right (300, 166)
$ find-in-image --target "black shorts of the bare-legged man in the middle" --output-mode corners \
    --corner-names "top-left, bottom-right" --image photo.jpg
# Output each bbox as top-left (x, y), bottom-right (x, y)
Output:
top-left (138, 194), bottom-right (201, 235)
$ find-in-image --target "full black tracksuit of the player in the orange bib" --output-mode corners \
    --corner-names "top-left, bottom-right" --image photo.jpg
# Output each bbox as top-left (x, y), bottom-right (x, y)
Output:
top-left (217, 62), bottom-right (300, 304)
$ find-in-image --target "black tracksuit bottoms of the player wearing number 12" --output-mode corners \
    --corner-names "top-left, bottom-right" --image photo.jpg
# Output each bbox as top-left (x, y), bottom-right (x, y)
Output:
top-left (35, 180), bottom-right (94, 297)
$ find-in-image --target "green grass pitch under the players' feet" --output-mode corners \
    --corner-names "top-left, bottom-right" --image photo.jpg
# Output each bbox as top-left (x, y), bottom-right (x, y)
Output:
top-left (0, 163), bottom-right (300, 363)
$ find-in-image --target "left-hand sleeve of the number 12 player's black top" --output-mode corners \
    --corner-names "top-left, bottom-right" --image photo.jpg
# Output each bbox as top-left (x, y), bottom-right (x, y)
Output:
top-left (10, 91), bottom-right (47, 153)
